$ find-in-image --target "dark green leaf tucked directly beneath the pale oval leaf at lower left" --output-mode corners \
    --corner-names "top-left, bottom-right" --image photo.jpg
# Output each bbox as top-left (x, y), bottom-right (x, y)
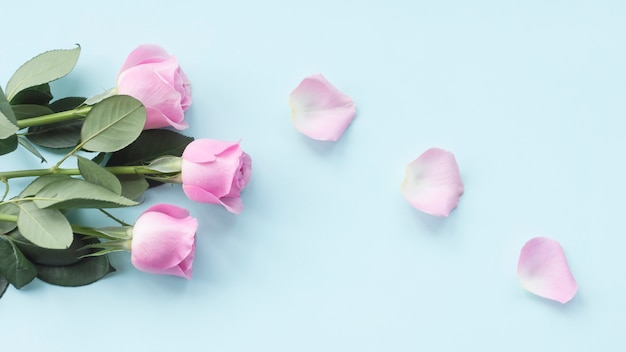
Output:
top-left (9, 231), bottom-right (93, 266)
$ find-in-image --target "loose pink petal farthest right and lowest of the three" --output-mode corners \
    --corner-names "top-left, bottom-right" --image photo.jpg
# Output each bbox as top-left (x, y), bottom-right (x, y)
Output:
top-left (517, 237), bottom-right (578, 303)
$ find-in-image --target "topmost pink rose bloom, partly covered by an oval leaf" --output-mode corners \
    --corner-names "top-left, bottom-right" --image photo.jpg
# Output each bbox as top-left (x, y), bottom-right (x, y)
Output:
top-left (117, 44), bottom-right (191, 130)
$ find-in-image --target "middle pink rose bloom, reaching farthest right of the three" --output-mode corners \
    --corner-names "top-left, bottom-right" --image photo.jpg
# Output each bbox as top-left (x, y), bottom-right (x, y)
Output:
top-left (181, 139), bottom-right (252, 214)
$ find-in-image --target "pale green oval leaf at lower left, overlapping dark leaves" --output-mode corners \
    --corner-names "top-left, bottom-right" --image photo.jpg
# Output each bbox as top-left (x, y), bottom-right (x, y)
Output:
top-left (17, 201), bottom-right (74, 249)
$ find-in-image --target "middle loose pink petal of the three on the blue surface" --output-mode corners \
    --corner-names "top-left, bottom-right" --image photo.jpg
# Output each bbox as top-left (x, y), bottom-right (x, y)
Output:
top-left (400, 148), bottom-right (464, 216)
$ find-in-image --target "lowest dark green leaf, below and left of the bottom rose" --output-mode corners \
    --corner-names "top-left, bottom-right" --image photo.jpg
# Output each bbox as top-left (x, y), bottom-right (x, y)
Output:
top-left (37, 250), bottom-right (115, 287)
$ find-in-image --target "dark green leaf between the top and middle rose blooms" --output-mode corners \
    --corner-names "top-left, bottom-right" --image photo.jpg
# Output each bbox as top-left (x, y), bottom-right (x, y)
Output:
top-left (107, 129), bottom-right (193, 166)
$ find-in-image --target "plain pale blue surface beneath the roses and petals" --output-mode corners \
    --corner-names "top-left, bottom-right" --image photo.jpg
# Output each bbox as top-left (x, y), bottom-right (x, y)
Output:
top-left (0, 0), bottom-right (626, 351)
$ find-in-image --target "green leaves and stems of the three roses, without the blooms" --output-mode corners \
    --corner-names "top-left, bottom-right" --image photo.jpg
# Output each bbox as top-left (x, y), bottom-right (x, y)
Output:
top-left (0, 46), bottom-right (193, 297)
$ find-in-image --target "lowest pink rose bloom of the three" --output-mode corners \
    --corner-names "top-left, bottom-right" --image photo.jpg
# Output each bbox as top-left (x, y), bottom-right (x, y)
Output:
top-left (131, 204), bottom-right (198, 279)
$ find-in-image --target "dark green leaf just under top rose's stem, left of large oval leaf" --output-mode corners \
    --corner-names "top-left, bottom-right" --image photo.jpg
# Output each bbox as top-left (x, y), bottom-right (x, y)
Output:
top-left (26, 120), bottom-right (83, 149)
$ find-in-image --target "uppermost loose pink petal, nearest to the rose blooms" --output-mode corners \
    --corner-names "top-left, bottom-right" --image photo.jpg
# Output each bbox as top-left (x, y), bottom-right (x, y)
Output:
top-left (289, 74), bottom-right (356, 141)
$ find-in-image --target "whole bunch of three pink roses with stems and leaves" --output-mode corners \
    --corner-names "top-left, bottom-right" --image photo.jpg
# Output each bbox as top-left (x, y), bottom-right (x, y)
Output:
top-left (0, 45), bottom-right (251, 297)
